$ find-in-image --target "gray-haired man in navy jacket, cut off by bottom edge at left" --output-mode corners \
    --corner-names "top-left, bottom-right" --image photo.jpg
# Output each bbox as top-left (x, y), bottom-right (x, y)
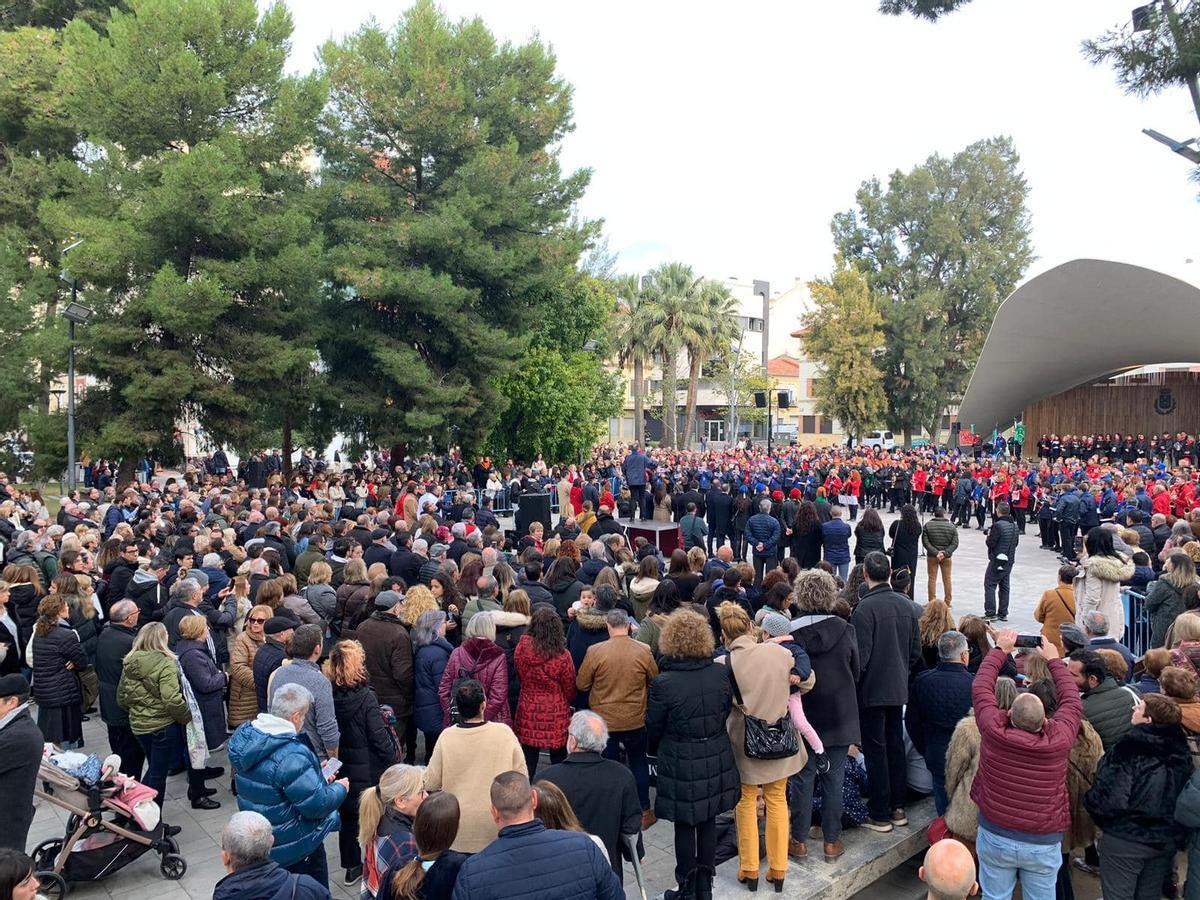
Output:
top-left (212, 811), bottom-right (330, 900)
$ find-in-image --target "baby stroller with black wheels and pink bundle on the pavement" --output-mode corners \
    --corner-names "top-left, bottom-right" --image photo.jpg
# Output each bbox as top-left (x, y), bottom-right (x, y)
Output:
top-left (30, 756), bottom-right (187, 900)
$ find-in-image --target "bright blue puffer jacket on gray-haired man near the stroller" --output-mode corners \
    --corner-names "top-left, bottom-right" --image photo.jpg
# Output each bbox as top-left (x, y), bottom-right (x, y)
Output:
top-left (229, 713), bottom-right (346, 865)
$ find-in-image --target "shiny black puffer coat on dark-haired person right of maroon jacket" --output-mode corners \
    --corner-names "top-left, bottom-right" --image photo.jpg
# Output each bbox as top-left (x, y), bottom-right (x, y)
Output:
top-left (1084, 725), bottom-right (1193, 851)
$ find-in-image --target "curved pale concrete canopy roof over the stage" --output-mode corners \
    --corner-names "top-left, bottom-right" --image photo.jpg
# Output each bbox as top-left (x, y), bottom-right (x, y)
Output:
top-left (959, 259), bottom-right (1200, 432)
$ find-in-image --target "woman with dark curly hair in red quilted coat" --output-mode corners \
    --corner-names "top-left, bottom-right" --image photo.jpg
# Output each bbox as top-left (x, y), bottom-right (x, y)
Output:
top-left (512, 606), bottom-right (575, 778)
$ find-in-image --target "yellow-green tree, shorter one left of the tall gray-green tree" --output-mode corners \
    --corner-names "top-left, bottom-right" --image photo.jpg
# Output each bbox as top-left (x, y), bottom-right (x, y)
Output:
top-left (800, 269), bottom-right (886, 438)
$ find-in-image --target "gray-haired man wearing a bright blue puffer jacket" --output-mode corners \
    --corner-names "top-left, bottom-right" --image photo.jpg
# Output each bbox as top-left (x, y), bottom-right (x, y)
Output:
top-left (229, 682), bottom-right (350, 890)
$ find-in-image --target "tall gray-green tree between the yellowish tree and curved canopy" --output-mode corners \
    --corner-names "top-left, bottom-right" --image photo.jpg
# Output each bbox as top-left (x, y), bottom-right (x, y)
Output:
top-left (833, 137), bottom-right (1033, 441)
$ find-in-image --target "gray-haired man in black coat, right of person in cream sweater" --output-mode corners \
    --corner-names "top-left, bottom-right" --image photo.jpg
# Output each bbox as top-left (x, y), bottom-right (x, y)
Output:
top-left (536, 709), bottom-right (642, 880)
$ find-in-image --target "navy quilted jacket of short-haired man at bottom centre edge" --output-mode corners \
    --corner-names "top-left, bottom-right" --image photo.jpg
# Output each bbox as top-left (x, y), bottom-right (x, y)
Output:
top-left (454, 820), bottom-right (625, 900)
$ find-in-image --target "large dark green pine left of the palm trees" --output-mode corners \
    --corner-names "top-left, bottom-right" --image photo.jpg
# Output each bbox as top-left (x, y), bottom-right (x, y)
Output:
top-left (320, 0), bottom-right (590, 458)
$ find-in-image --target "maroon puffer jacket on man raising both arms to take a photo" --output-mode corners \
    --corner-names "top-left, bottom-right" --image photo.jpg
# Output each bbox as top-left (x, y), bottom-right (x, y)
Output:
top-left (971, 649), bottom-right (1084, 834)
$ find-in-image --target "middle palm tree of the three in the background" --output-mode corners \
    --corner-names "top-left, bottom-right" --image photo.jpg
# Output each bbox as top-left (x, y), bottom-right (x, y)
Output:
top-left (646, 263), bottom-right (704, 446)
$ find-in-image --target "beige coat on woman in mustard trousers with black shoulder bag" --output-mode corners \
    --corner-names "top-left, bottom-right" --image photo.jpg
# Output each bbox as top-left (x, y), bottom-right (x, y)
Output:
top-left (722, 635), bottom-right (816, 785)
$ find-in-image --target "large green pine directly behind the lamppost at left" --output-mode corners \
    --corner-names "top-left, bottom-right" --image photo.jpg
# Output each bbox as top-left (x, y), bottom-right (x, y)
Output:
top-left (41, 0), bottom-right (325, 476)
